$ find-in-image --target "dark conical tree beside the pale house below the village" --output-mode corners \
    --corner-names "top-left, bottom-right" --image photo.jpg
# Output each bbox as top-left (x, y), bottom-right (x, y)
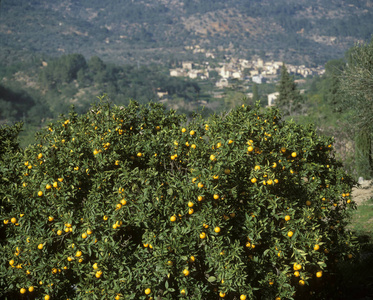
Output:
top-left (275, 64), bottom-right (302, 116)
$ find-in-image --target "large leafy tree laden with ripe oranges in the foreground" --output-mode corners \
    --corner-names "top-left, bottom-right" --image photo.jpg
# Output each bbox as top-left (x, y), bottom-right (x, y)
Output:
top-left (0, 102), bottom-right (356, 300)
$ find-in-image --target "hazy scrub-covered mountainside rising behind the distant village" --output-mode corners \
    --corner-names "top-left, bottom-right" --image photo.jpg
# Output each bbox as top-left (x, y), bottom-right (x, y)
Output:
top-left (0, 0), bottom-right (373, 65)
